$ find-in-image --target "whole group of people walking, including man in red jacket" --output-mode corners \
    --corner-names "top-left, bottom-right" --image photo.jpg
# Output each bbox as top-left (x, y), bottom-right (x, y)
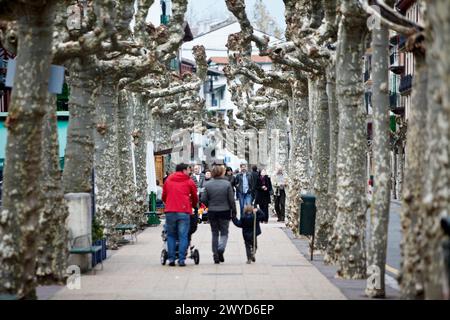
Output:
top-left (162, 163), bottom-right (286, 266)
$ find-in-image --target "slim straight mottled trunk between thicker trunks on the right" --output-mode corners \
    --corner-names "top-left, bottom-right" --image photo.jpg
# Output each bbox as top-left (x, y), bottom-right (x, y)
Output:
top-left (366, 21), bottom-right (391, 297)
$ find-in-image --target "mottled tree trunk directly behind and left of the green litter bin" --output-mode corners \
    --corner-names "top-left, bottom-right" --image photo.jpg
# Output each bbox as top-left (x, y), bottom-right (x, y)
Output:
top-left (286, 79), bottom-right (310, 234)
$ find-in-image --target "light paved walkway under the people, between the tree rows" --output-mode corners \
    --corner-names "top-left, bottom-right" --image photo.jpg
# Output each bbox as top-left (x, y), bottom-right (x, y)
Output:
top-left (38, 215), bottom-right (345, 300)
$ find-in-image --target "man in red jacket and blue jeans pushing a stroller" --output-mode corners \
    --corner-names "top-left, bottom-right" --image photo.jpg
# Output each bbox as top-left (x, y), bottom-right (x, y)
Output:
top-left (162, 163), bottom-right (198, 267)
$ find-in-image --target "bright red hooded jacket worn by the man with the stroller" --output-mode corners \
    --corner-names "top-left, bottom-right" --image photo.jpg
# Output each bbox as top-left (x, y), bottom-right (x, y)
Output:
top-left (162, 172), bottom-right (198, 214)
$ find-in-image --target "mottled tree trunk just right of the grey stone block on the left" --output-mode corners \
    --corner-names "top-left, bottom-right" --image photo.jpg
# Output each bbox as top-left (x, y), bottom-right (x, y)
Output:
top-left (94, 80), bottom-right (123, 249)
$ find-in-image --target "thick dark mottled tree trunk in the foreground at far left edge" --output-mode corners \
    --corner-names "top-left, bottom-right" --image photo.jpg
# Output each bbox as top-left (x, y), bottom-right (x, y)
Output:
top-left (0, 2), bottom-right (54, 298)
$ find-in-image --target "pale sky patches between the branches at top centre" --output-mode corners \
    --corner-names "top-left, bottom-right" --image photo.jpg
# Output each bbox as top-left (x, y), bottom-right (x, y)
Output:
top-left (187, 0), bottom-right (286, 32)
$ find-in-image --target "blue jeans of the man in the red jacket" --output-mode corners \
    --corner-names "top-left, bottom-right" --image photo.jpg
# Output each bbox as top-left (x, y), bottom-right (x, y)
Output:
top-left (166, 212), bottom-right (191, 263)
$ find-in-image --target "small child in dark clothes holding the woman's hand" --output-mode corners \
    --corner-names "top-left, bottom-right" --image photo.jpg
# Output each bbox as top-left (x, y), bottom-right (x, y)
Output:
top-left (233, 205), bottom-right (264, 264)
